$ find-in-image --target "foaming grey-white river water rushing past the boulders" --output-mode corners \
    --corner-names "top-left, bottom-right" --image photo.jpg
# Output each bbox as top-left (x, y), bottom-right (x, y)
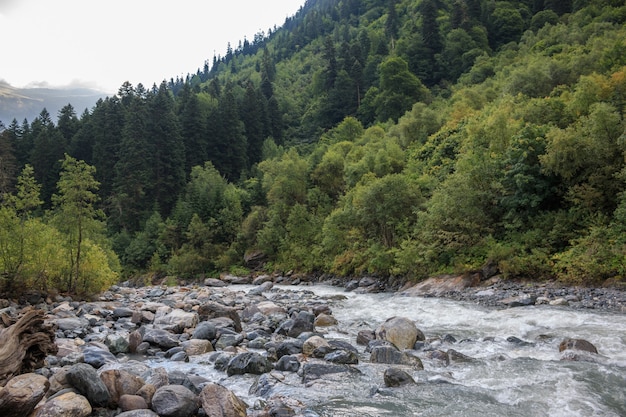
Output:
top-left (145, 286), bottom-right (626, 417)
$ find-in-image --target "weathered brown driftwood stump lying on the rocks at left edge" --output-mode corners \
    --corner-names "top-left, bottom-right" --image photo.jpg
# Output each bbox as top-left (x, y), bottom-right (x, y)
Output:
top-left (0, 309), bottom-right (57, 387)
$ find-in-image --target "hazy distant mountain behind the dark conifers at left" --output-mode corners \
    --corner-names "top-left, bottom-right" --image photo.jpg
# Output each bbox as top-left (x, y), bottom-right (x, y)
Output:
top-left (0, 80), bottom-right (110, 125)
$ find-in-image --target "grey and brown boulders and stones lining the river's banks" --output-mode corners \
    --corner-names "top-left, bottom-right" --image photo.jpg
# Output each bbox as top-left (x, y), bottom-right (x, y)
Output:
top-left (0, 276), bottom-right (626, 417)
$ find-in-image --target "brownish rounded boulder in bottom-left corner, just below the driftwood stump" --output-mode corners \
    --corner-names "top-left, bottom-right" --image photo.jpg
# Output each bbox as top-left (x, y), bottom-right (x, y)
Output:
top-left (0, 373), bottom-right (50, 417)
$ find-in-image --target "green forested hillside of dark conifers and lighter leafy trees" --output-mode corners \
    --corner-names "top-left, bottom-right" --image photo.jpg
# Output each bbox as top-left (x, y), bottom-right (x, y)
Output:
top-left (0, 0), bottom-right (626, 293)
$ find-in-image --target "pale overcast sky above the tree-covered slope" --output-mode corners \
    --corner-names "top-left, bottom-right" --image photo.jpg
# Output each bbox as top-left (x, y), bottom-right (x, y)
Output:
top-left (0, 0), bottom-right (305, 93)
